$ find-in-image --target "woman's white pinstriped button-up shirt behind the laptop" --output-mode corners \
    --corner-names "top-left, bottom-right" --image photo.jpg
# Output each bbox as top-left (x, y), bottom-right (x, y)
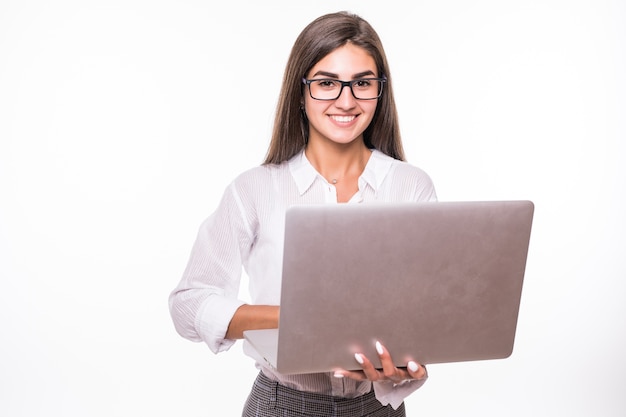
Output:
top-left (169, 150), bottom-right (437, 407)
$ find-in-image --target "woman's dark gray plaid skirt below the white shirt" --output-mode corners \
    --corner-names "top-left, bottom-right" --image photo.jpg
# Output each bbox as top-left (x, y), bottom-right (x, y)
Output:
top-left (242, 372), bottom-right (406, 417)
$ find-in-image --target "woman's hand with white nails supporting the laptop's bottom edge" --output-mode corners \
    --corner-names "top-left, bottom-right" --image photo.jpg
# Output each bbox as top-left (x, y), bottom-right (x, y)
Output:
top-left (335, 342), bottom-right (428, 384)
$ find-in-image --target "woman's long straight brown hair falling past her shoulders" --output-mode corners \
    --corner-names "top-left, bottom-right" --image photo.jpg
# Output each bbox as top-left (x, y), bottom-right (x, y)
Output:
top-left (264, 12), bottom-right (404, 164)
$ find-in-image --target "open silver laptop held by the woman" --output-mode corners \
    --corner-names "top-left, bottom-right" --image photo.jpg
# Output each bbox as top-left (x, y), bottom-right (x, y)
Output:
top-left (244, 201), bottom-right (534, 374)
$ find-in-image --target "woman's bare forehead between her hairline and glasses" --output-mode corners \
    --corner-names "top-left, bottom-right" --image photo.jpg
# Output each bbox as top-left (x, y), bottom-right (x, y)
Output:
top-left (307, 43), bottom-right (377, 79)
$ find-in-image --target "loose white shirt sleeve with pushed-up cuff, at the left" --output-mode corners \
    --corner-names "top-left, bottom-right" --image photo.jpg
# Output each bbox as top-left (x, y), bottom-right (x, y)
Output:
top-left (169, 184), bottom-right (254, 353)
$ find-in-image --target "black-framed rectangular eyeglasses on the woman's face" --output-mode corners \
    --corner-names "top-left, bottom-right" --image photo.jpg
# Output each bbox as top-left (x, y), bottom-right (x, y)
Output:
top-left (302, 77), bottom-right (387, 100)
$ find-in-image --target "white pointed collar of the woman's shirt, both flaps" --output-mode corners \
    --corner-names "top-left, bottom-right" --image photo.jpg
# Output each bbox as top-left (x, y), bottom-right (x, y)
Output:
top-left (288, 149), bottom-right (394, 195)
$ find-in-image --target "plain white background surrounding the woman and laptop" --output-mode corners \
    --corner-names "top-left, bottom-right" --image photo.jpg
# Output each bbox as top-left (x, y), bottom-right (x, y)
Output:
top-left (0, 0), bottom-right (626, 417)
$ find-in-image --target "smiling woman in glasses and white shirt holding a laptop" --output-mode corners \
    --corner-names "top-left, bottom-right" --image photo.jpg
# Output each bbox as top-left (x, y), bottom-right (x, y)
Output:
top-left (170, 12), bottom-right (436, 416)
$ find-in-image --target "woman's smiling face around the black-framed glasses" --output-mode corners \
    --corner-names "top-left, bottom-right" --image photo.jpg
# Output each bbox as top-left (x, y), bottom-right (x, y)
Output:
top-left (304, 43), bottom-right (378, 144)
